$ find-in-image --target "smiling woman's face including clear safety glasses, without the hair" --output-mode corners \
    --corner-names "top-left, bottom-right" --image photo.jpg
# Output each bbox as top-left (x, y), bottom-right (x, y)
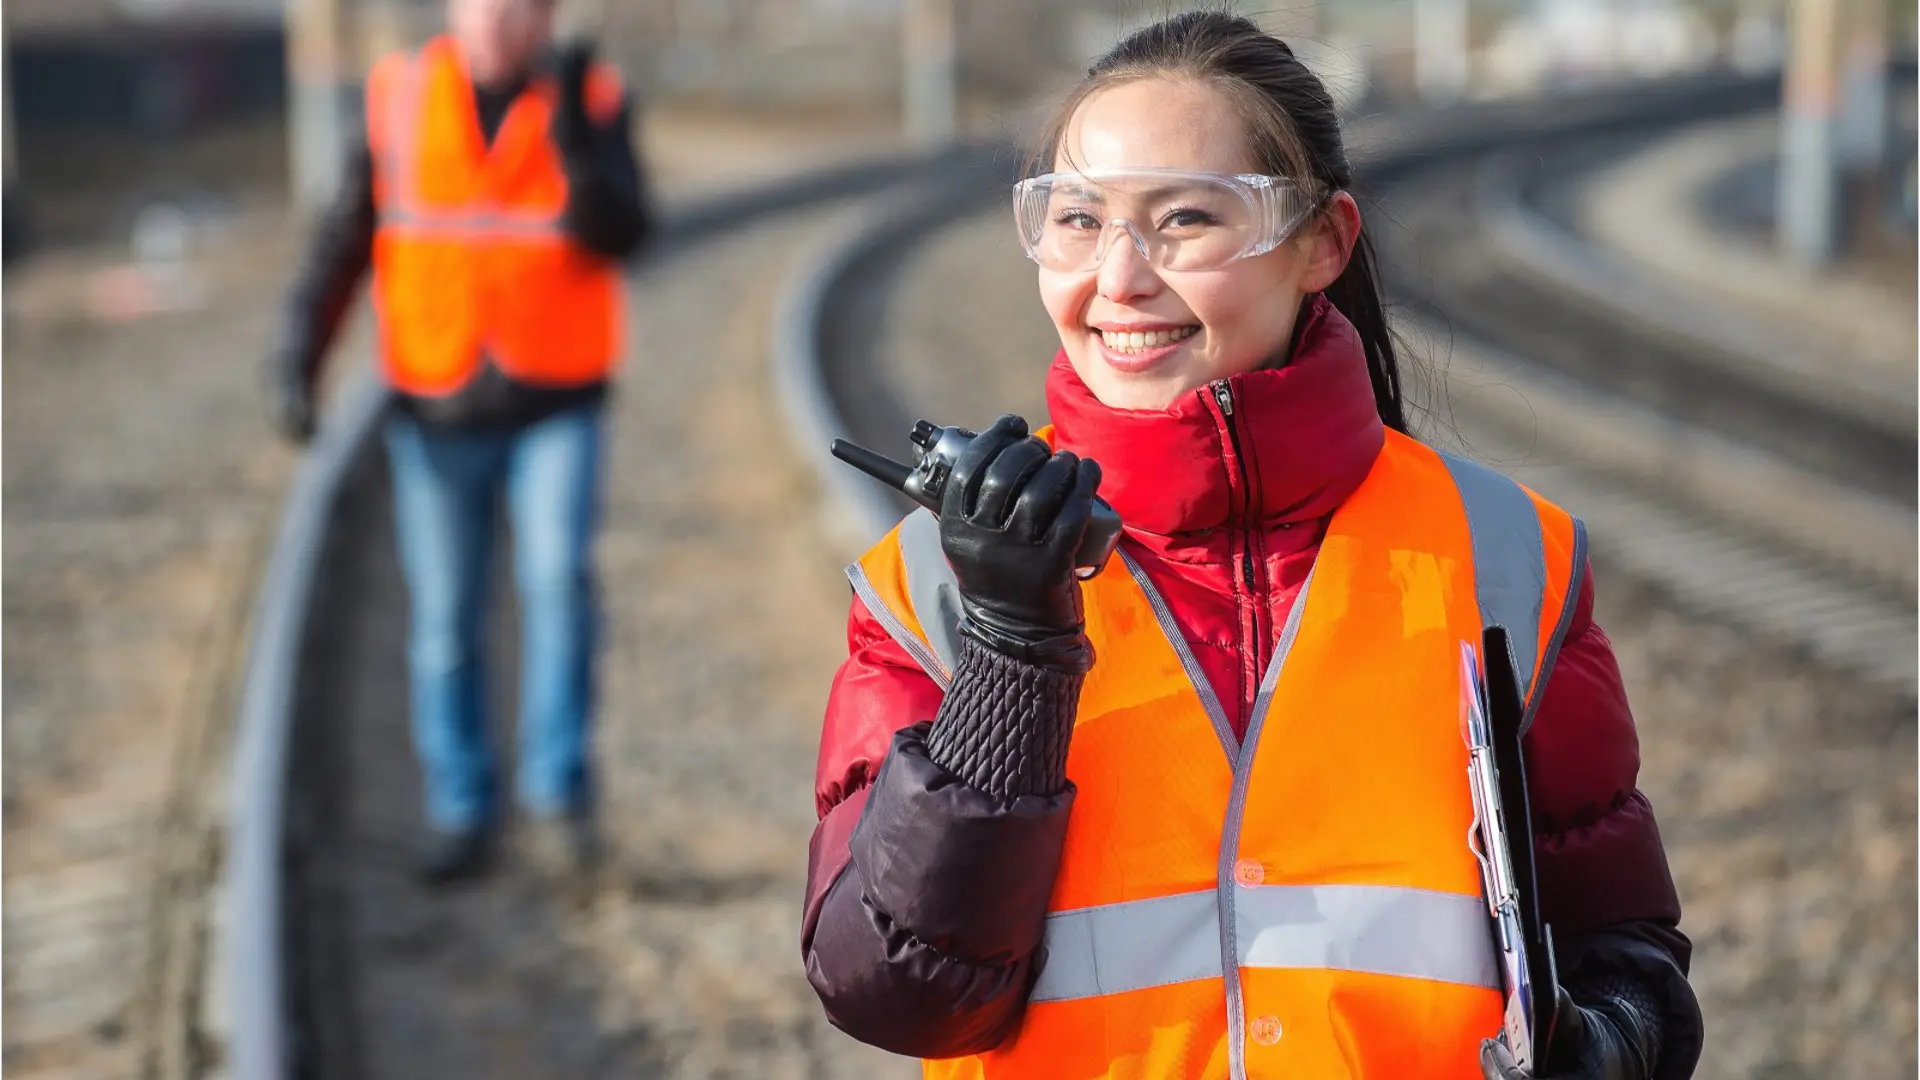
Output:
top-left (1016, 77), bottom-right (1359, 409)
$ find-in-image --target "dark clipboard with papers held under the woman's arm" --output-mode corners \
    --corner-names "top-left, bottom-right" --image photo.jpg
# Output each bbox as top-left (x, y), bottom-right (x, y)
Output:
top-left (1459, 626), bottom-right (1559, 1074)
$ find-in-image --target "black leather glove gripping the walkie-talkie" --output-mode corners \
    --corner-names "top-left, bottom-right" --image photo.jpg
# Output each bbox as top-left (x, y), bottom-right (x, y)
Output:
top-left (941, 415), bottom-right (1100, 673)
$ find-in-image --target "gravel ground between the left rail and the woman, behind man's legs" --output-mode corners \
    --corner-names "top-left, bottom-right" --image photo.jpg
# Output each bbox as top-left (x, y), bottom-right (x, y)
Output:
top-left (286, 199), bottom-right (916, 1080)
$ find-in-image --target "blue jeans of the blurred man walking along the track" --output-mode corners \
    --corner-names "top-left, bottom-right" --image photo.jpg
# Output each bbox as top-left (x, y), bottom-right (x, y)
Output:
top-left (386, 405), bottom-right (603, 830)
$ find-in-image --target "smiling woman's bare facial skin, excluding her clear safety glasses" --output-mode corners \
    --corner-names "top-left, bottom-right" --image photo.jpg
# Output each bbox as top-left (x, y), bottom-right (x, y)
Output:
top-left (1041, 79), bottom-right (1359, 409)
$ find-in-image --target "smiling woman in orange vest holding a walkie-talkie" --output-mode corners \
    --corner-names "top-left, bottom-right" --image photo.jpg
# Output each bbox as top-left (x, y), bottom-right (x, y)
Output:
top-left (803, 12), bottom-right (1701, 1080)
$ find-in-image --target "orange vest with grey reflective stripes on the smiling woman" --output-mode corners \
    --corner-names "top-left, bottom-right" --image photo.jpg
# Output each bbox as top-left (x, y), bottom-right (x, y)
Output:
top-left (849, 432), bottom-right (1586, 1080)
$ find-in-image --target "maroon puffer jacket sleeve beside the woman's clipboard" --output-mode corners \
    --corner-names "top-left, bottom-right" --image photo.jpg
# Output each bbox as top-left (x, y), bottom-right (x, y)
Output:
top-left (1524, 567), bottom-right (1701, 1080)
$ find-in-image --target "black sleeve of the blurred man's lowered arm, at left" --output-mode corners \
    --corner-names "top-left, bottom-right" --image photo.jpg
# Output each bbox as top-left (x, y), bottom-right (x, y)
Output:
top-left (276, 136), bottom-right (374, 388)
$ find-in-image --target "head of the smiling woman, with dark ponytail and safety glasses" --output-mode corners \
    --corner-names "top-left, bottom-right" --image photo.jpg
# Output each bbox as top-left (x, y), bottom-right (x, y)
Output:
top-left (1016, 31), bottom-right (1405, 422)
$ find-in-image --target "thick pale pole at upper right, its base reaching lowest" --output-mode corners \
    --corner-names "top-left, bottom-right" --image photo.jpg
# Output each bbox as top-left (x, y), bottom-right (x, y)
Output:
top-left (1774, 0), bottom-right (1841, 267)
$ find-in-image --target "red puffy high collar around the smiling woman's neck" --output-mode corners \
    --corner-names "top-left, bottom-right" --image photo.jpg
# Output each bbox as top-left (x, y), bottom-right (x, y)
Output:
top-left (1046, 296), bottom-right (1386, 536)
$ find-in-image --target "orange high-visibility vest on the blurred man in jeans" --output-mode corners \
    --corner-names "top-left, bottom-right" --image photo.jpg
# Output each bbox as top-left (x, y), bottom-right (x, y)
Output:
top-left (367, 38), bottom-right (620, 396)
